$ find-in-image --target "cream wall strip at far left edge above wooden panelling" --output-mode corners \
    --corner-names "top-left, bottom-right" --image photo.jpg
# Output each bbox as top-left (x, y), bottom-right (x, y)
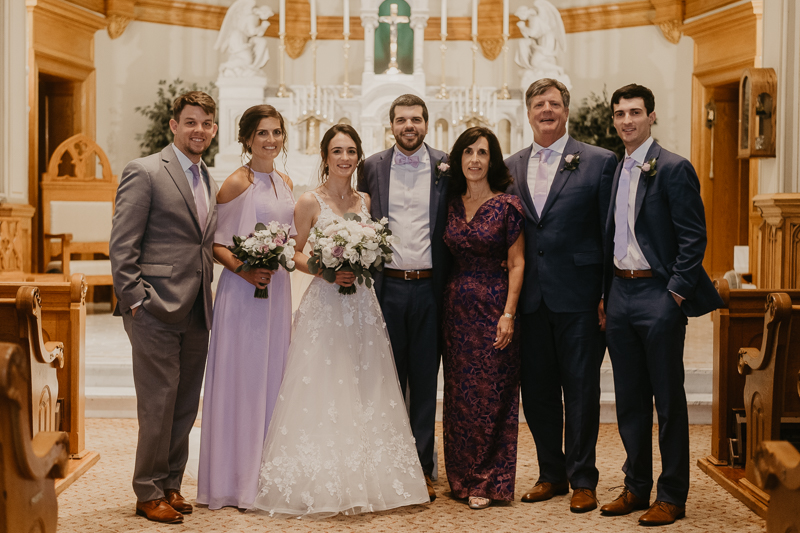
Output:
top-left (0, 2), bottom-right (28, 204)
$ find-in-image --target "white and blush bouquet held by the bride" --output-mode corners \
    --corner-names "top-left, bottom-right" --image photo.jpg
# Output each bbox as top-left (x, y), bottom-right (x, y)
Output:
top-left (308, 213), bottom-right (394, 294)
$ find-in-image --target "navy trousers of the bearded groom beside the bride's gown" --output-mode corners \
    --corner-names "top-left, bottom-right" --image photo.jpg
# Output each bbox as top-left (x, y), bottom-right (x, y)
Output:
top-left (381, 276), bottom-right (439, 475)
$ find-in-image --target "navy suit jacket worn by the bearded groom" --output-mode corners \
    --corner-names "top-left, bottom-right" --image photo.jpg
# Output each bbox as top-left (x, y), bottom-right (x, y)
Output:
top-left (358, 143), bottom-right (452, 317)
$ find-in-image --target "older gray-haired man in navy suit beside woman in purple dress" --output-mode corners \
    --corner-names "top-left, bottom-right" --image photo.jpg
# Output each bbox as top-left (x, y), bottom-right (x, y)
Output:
top-left (506, 78), bottom-right (617, 513)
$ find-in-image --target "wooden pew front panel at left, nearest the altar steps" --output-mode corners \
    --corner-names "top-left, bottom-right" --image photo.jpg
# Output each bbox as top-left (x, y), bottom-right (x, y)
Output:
top-left (0, 274), bottom-right (100, 494)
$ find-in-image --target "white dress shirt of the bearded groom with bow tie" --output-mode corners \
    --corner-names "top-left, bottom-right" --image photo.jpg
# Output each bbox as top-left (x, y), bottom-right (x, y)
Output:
top-left (387, 144), bottom-right (433, 270)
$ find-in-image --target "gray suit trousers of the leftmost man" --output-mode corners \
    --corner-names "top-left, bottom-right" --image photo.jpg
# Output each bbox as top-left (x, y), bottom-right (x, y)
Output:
top-left (122, 295), bottom-right (208, 501)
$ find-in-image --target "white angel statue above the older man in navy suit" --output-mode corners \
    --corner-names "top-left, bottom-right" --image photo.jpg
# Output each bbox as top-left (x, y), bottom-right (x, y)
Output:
top-left (515, 0), bottom-right (572, 92)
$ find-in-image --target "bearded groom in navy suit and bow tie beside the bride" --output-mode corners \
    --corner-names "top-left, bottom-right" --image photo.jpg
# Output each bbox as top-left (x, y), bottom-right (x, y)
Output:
top-left (358, 94), bottom-right (450, 501)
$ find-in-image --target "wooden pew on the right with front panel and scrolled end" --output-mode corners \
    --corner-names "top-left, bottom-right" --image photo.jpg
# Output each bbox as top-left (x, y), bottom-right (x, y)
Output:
top-left (698, 281), bottom-right (800, 517)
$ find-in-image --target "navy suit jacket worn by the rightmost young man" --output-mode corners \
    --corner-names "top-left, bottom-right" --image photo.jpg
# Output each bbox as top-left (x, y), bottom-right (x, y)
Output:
top-left (605, 142), bottom-right (722, 316)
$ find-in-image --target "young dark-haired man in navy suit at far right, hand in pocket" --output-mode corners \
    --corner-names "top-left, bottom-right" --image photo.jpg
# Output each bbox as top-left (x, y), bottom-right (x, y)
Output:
top-left (600, 84), bottom-right (722, 526)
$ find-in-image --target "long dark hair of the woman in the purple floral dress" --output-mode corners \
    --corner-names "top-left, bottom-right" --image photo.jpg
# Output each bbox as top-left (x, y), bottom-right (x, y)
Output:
top-left (448, 126), bottom-right (514, 198)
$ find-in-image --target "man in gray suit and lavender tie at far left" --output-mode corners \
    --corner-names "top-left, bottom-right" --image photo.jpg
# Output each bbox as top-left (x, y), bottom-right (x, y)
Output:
top-left (109, 91), bottom-right (217, 523)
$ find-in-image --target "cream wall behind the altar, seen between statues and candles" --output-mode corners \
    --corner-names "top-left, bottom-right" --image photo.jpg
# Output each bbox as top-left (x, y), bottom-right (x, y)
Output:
top-left (95, 7), bottom-right (693, 173)
